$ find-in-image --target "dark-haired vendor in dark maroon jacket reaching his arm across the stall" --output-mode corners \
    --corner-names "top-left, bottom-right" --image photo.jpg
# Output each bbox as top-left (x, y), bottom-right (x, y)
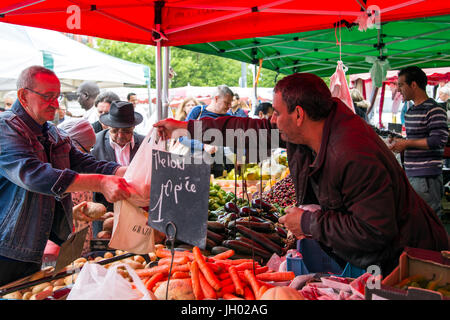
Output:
top-left (154, 73), bottom-right (448, 276)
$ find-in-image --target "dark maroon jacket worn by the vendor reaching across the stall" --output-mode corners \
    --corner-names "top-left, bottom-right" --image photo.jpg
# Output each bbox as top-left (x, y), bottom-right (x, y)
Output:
top-left (188, 99), bottom-right (449, 275)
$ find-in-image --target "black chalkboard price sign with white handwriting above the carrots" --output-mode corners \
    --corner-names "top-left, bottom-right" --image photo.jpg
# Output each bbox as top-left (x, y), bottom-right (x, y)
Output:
top-left (148, 150), bottom-right (211, 249)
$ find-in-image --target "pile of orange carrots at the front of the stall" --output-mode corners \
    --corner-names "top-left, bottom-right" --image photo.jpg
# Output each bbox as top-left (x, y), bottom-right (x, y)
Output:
top-left (135, 247), bottom-right (295, 300)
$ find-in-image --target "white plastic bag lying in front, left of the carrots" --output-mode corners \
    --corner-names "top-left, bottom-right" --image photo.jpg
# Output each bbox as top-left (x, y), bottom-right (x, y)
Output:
top-left (67, 263), bottom-right (156, 300)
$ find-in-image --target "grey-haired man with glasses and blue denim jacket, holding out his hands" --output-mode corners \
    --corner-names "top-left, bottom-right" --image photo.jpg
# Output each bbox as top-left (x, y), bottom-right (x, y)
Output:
top-left (0, 66), bottom-right (132, 286)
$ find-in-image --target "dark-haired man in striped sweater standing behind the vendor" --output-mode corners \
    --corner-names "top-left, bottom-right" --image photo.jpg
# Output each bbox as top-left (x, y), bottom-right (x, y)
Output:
top-left (390, 66), bottom-right (448, 217)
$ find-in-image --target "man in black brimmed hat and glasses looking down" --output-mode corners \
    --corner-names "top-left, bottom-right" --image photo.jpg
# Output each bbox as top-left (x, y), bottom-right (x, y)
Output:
top-left (91, 101), bottom-right (145, 237)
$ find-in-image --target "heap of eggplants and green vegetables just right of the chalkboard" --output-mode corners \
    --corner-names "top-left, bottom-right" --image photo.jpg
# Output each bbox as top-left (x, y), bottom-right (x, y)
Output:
top-left (206, 184), bottom-right (295, 261)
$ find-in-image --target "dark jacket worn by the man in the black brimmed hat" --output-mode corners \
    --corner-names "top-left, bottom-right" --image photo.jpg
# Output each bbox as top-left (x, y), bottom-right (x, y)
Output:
top-left (91, 129), bottom-right (145, 211)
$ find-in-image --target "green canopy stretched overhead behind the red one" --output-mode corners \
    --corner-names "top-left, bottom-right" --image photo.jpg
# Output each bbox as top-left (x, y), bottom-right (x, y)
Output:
top-left (179, 15), bottom-right (450, 77)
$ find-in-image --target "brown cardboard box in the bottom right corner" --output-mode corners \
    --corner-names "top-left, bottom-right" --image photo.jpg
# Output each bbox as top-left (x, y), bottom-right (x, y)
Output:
top-left (365, 248), bottom-right (450, 300)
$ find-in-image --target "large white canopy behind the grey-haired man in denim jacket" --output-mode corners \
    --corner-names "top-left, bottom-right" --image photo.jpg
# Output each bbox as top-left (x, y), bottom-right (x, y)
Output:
top-left (0, 23), bottom-right (150, 92)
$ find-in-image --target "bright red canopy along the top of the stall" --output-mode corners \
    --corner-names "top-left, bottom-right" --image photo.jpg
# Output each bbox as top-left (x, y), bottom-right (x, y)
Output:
top-left (0, 0), bottom-right (450, 46)
